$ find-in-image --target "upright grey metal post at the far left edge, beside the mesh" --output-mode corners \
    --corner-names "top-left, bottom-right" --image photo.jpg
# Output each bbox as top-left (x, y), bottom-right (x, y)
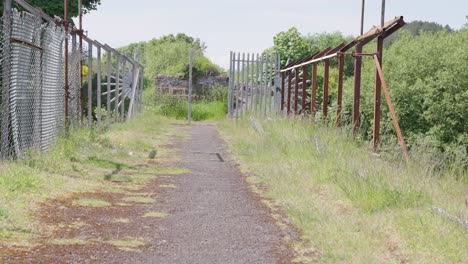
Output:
top-left (1, 0), bottom-right (12, 160)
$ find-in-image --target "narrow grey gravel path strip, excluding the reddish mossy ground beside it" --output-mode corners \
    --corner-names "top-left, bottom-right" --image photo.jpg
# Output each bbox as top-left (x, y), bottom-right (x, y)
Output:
top-left (140, 125), bottom-right (290, 263)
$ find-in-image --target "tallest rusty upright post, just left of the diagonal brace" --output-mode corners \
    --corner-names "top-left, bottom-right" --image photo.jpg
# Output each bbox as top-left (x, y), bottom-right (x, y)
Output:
top-left (372, 36), bottom-right (384, 151)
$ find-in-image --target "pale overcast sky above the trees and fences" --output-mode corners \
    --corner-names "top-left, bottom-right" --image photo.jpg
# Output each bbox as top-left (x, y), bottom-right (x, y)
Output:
top-left (83, 0), bottom-right (468, 67)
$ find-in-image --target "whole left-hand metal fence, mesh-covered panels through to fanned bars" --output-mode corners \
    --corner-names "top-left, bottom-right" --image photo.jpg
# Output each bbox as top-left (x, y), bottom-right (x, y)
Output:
top-left (0, 0), bottom-right (143, 160)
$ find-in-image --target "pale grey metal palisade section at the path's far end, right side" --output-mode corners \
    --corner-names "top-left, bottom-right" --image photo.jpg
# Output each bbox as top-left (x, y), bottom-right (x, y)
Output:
top-left (228, 52), bottom-right (281, 118)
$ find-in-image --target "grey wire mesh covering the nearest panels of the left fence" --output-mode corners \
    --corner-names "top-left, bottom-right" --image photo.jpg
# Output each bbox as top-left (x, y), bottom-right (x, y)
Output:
top-left (1, 10), bottom-right (63, 158)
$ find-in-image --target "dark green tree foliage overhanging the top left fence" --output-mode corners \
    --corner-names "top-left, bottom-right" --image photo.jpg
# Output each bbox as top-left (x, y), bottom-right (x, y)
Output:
top-left (0, 0), bottom-right (101, 17)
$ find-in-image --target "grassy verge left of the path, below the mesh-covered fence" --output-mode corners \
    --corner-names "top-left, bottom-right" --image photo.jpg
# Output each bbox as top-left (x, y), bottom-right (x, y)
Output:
top-left (0, 107), bottom-right (174, 243)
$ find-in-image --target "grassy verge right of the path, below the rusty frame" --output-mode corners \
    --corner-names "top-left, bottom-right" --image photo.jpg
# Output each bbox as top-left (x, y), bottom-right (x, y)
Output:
top-left (220, 116), bottom-right (468, 263)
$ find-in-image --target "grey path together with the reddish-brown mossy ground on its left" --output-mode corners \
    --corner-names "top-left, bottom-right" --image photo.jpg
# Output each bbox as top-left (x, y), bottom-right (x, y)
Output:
top-left (0, 124), bottom-right (292, 264)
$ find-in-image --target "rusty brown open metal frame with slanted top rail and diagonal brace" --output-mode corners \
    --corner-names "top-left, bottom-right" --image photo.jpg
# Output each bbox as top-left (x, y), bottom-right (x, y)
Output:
top-left (279, 17), bottom-right (407, 156)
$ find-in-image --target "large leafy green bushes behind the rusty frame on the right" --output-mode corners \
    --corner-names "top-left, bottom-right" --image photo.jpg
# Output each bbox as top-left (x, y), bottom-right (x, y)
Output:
top-left (345, 29), bottom-right (468, 173)
